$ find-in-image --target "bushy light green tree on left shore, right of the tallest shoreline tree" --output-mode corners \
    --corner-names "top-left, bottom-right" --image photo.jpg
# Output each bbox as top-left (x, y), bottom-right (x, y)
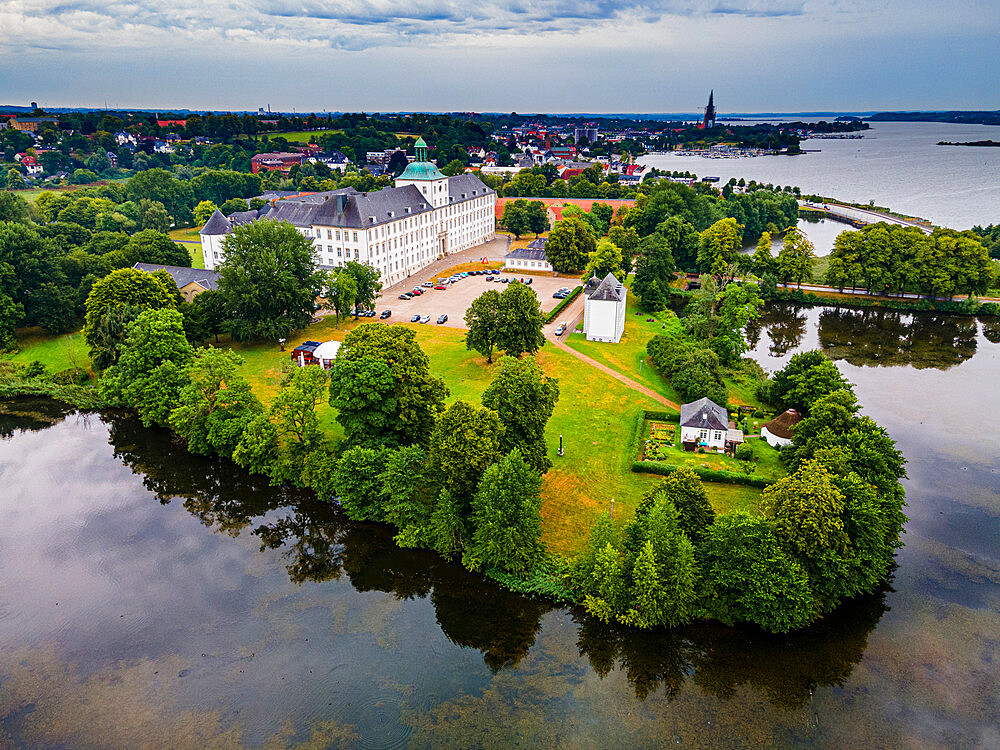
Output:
top-left (169, 349), bottom-right (264, 457)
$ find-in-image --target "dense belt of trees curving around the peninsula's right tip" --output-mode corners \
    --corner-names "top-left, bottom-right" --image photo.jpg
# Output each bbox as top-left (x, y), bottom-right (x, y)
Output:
top-left (571, 352), bottom-right (905, 632)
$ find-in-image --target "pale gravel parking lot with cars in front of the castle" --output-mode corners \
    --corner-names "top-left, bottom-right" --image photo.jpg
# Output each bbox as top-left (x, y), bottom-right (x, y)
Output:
top-left (374, 271), bottom-right (580, 328)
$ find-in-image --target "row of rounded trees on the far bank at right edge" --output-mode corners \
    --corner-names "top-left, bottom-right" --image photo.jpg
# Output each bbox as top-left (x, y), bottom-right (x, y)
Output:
top-left (826, 223), bottom-right (993, 297)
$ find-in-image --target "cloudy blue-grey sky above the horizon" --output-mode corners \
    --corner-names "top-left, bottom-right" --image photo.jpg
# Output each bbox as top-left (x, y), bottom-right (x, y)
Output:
top-left (0, 0), bottom-right (1000, 112)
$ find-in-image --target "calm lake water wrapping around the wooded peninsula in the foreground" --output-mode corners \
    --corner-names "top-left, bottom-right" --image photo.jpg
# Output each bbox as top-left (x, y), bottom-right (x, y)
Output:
top-left (0, 308), bottom-right (1000, 748)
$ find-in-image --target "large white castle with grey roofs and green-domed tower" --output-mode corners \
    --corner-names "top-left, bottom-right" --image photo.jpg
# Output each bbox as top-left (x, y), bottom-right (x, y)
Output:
top-left (200, 138), bottom-right (497, 287)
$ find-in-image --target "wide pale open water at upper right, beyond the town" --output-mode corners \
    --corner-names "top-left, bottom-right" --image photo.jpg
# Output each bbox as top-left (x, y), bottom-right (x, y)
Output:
top-left (639, 122), bottom-right (1000, 229)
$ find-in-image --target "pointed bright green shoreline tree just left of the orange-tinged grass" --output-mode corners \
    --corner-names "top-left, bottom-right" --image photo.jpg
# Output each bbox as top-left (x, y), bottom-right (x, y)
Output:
top-left (463, 449), bottom-right (543, 576)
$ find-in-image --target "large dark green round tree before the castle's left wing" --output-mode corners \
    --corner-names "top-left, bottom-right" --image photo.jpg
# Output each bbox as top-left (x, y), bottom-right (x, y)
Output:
top-left (219, 221), bottom-right (323, 341)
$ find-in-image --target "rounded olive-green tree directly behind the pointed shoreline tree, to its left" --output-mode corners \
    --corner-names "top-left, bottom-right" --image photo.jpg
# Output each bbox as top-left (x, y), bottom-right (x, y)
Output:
top-left (430, 401), bottom-right (504, 500)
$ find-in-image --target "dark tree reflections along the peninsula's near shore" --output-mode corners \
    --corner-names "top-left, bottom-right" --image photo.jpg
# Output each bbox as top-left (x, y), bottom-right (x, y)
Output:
top-left (99, 417), bottom-right (884, 708)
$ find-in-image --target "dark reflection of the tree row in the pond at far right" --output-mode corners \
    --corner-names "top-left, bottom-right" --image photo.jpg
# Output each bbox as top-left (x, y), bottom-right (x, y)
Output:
top-left (819, 308), bottom-right (976, 370)
